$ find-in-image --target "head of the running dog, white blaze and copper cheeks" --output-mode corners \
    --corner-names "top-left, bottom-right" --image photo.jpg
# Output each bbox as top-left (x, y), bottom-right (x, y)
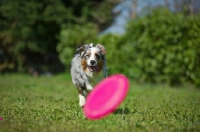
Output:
top-left (77, 44), bottom-right (106, 72)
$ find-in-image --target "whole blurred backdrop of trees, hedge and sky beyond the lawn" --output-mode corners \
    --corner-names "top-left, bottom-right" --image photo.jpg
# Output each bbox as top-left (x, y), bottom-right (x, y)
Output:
top-left (0, 0), bottom-right (200, 87)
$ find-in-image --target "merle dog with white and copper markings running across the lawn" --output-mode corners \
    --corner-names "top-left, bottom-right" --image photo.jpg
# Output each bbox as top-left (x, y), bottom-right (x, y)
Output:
top-left (70, 43), bottom-right (108, 107)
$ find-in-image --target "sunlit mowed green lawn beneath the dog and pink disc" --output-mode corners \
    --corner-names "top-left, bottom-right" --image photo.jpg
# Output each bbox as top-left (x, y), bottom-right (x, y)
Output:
top-left (0, 73), bottom-right (200, 132)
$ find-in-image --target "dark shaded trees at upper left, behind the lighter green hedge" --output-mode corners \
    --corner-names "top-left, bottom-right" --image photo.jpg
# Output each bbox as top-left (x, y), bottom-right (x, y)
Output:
top-left (0, 0), bottom-right (114, 71)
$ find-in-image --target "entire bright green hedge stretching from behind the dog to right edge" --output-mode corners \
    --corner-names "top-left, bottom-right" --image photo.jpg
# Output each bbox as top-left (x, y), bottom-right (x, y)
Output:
top-left (58, 9), bottom-right (200, 85)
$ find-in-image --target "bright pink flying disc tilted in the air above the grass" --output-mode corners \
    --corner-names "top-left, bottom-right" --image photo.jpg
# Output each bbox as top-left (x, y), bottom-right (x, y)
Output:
top-left (83, 74), bottom-right (129, 120)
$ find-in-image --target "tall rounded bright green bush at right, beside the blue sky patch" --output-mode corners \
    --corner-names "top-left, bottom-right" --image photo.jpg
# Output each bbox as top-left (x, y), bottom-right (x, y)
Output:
top-left (125, 9), bottom-right (200, 85)
